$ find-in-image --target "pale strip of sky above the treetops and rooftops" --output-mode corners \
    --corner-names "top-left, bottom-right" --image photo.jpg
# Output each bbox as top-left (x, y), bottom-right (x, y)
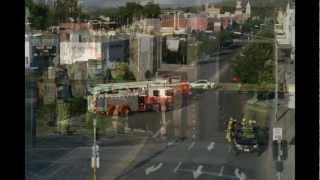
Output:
top-left (81, 0), bottom-right (220, 7)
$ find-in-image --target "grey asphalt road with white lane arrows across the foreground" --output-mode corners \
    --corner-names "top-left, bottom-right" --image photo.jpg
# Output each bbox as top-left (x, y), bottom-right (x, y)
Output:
top-left (27, 44), bottom-right (271, 180)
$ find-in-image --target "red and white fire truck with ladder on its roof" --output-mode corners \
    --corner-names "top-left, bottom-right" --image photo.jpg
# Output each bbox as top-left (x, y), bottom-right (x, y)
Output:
top-left (88, 80), bottom-right (191, 115)
